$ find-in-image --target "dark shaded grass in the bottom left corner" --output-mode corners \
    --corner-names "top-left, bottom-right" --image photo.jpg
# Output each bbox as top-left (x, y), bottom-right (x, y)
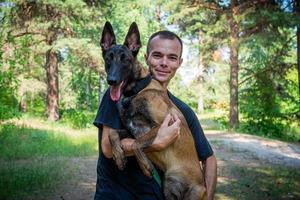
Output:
top-left (0, 157), bottom-right (71, 199)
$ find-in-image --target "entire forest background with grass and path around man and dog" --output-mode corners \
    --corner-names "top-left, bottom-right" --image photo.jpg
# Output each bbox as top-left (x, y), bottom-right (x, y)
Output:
top-left (0, 0), bottom-right (300, 200)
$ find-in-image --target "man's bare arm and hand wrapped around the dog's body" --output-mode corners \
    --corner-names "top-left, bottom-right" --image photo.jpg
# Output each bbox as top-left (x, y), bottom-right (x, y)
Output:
top-left (101, 114), bottom-right (181, 158)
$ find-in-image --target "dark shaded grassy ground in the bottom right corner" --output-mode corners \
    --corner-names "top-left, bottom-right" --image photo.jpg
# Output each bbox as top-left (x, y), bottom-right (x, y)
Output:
top-left (216, 166), bottom-right (300, 200)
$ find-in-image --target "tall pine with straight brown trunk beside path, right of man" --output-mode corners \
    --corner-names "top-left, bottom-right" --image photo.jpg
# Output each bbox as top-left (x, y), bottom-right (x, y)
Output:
top-left (164, 0), bottom-right (292, 128)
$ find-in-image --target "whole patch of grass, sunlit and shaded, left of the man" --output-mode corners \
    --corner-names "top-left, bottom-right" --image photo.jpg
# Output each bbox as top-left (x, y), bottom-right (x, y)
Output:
top-left (0, 117), bottom-right (98, 200)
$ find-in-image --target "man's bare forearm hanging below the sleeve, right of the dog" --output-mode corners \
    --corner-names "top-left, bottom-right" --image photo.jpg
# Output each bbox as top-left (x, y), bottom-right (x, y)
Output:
top-left (204, 155), bottom-right (217, 200)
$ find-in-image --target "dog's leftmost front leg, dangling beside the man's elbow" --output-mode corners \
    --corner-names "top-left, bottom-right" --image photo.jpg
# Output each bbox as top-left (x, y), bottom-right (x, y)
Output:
top-left (108, 129), bottom-right (126, 170)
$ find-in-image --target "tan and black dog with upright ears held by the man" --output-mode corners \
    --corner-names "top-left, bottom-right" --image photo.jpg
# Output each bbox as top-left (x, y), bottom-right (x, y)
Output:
top-left (100, 22), bottom-right (206, 200)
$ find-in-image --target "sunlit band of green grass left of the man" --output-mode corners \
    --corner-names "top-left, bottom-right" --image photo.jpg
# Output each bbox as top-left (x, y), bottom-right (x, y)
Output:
top-left (0, 124), bottom-right (97, 160)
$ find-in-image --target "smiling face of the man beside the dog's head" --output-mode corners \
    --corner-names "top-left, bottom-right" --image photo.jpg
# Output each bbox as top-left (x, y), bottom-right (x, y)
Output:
top-left (145, 36), bottom-right (182, 85)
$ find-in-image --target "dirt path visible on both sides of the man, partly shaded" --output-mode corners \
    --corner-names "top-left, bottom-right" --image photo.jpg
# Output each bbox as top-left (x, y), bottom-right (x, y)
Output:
top-left (53, 131), bottom-right (300, 200)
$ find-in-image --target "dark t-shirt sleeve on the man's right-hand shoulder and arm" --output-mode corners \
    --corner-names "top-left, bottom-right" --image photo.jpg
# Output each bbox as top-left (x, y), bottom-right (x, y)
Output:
top-left (169, 93), bottom-right (214, 161)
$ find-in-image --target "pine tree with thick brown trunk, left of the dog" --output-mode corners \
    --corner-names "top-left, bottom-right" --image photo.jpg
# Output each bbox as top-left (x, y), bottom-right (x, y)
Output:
top-left (8, 0), bottom-right (101, 120)
